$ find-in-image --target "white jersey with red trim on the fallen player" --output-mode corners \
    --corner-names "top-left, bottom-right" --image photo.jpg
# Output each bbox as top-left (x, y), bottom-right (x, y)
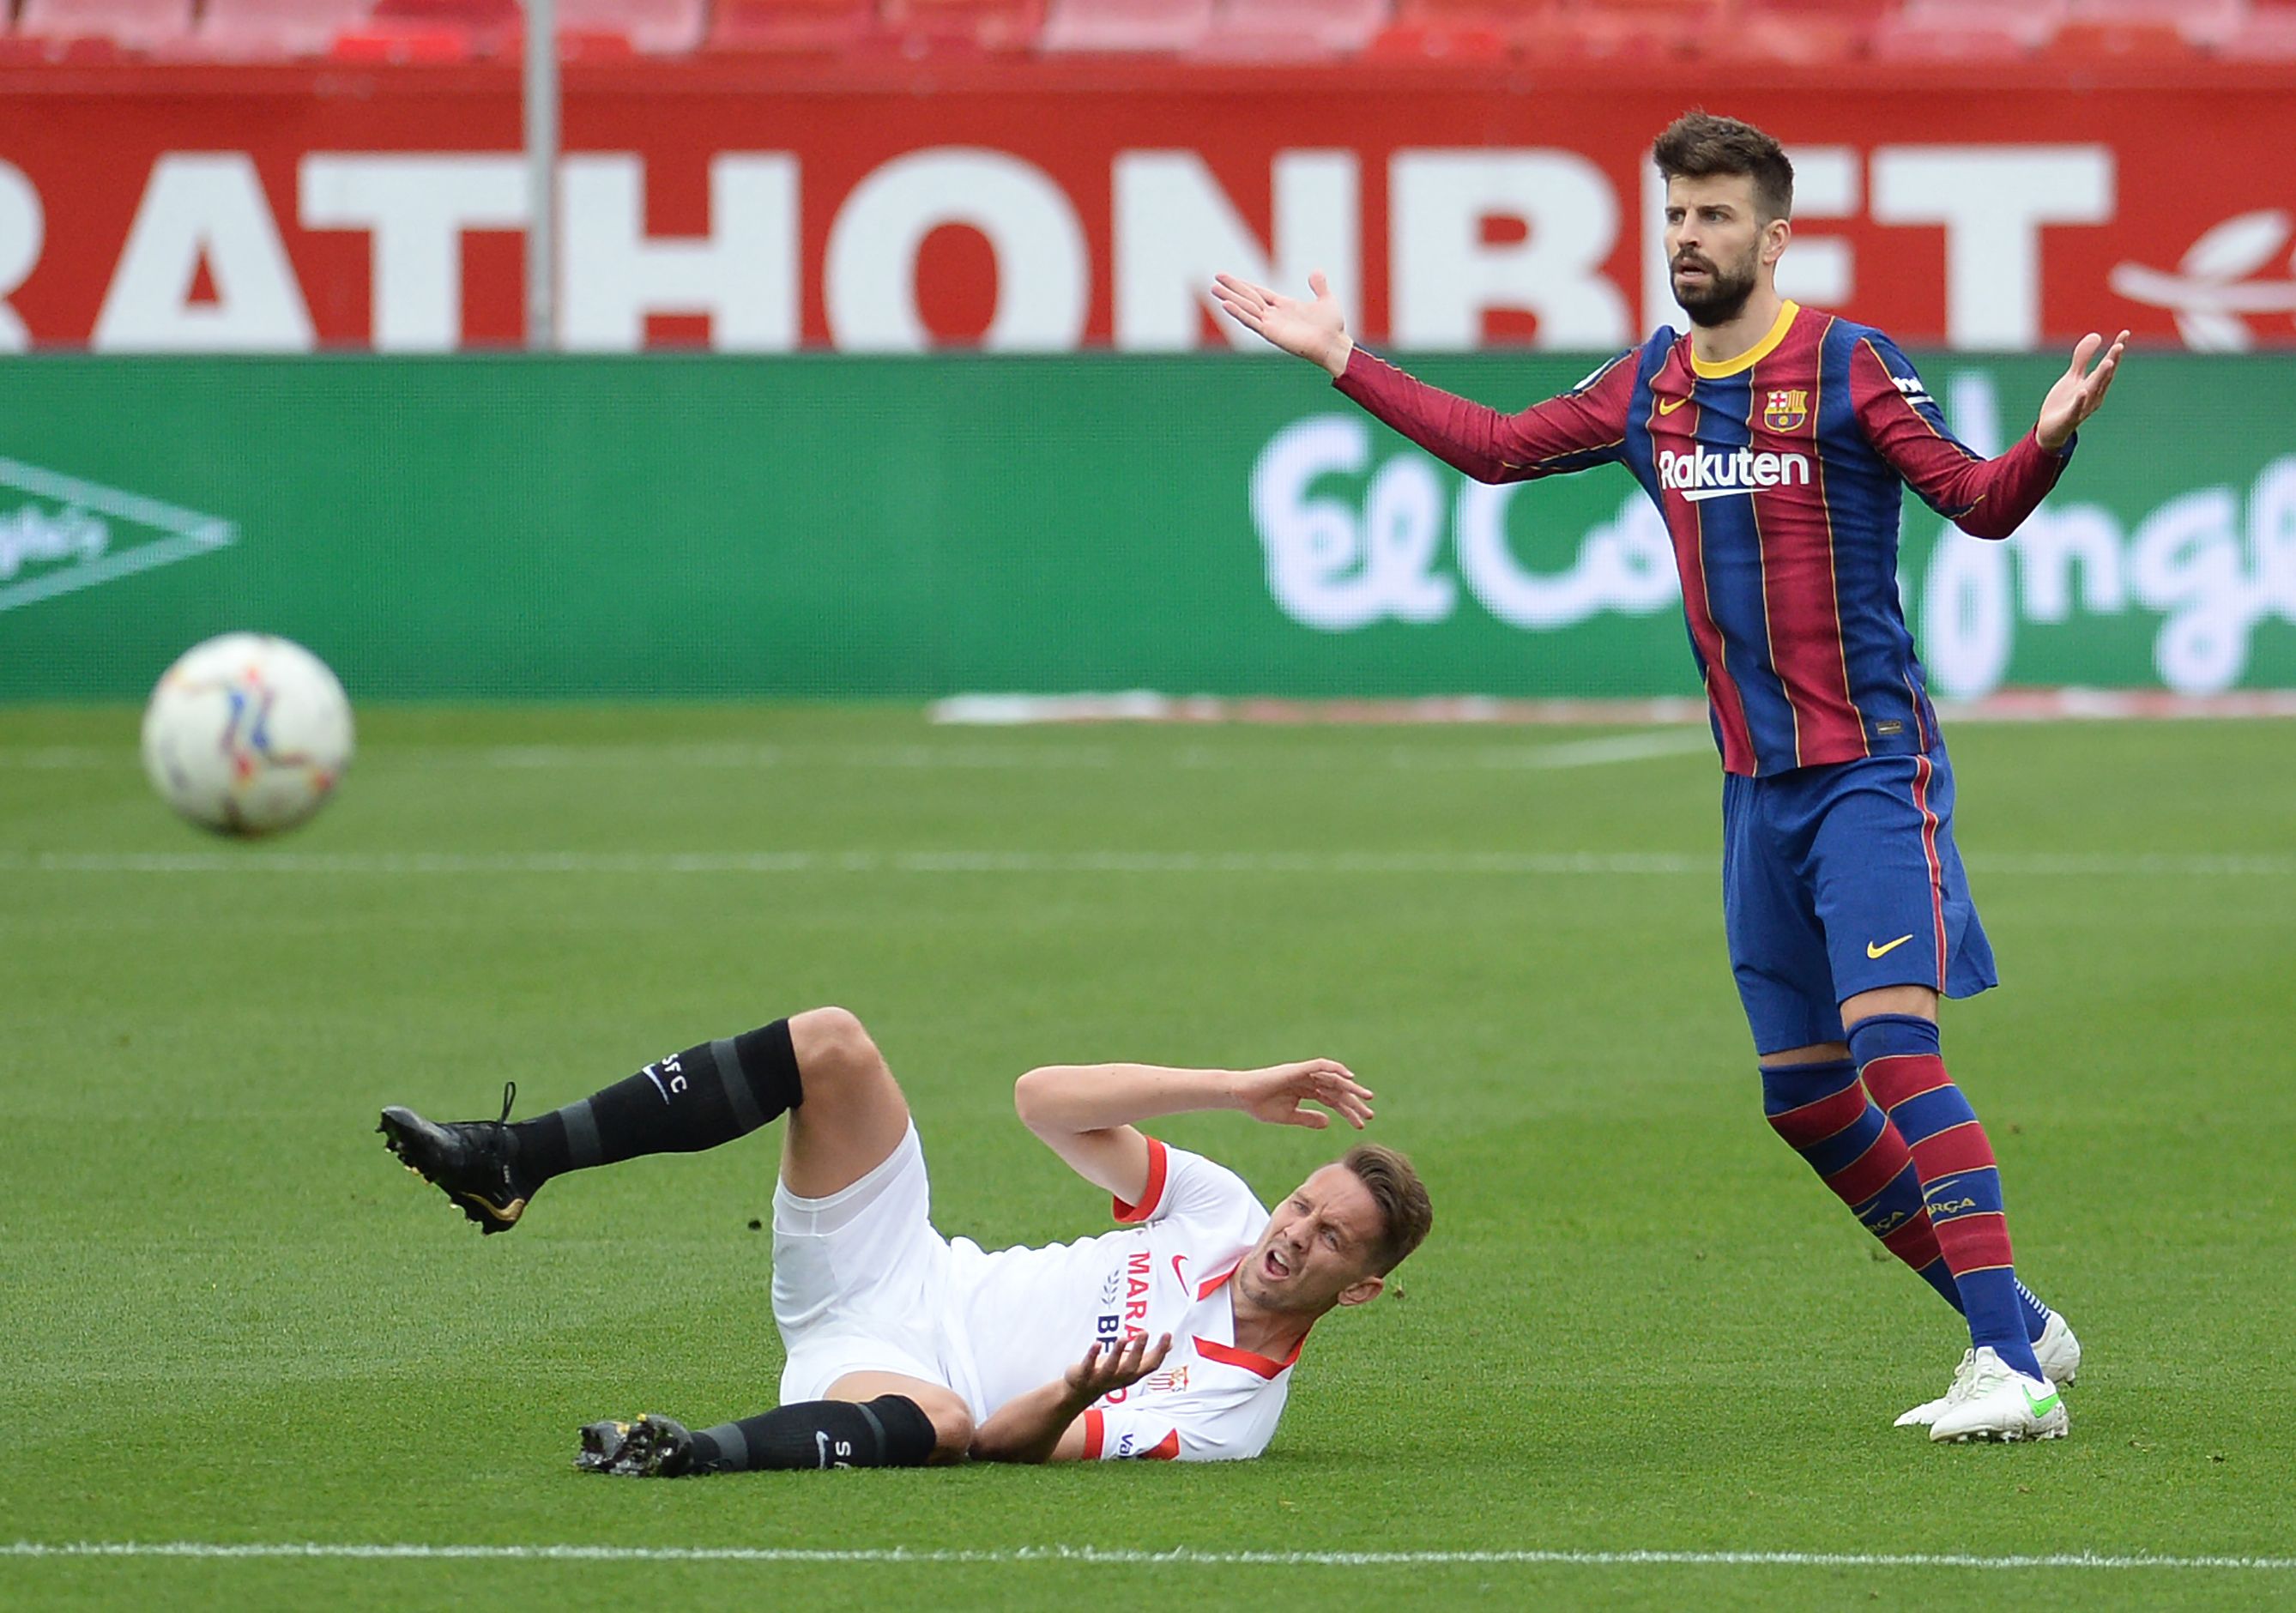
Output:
top-left (951, 1138), bottom-right (1300, 1461)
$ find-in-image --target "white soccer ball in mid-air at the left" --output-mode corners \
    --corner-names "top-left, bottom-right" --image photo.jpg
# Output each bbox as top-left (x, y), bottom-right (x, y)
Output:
top-left (145, 633), bottom-right (351, 835)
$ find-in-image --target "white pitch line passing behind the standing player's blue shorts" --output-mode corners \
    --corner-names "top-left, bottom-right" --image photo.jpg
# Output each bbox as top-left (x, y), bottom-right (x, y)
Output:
top-left (0, 849), bottom-right (2296, 879)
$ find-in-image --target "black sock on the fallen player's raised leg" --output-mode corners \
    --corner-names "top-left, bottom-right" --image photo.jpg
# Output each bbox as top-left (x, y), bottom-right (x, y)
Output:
top-left (510, 1018), bottom-right (806, 1193)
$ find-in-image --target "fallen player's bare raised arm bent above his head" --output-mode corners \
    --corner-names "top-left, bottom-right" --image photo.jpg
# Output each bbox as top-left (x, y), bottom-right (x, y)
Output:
top-left (1012, 1058), bottom-right (1371, 1205)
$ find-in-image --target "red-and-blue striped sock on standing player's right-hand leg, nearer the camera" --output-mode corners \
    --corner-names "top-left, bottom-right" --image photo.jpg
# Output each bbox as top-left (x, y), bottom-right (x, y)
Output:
top-left (1851, 1014), bottom-right (2041, 1377)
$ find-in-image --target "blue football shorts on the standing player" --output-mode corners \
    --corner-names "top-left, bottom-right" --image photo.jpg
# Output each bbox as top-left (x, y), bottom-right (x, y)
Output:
top-left (1722, 748), bottom-right (2000, 1053)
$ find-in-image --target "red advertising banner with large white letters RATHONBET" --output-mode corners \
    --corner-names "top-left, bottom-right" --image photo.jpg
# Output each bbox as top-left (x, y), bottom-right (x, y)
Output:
top-left (0, 67), bottom-right (2296, 351)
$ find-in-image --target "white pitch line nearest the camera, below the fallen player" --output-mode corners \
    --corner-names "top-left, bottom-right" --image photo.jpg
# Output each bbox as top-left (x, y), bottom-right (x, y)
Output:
top-left (0, 1539), bottom-right (2296, 1574)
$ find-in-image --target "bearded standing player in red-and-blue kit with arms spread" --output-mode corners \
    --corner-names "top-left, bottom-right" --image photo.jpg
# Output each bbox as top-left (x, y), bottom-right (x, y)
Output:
top-left (1215, 112), bottom-right (2129, 1441)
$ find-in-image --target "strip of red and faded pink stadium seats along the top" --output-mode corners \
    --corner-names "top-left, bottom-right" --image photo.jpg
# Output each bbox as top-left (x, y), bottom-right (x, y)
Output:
top-left (0, 0), bottom-right (2296, 71)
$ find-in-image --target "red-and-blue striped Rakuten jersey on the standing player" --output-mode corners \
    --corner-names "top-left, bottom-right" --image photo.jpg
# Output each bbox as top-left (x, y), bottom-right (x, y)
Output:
top-left (1336, 303), bottom-right (2073, 776)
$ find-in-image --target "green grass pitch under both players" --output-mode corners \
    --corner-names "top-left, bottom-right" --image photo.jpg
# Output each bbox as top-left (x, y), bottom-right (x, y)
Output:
top-left (0, 709), bottom-right (2296, 1609)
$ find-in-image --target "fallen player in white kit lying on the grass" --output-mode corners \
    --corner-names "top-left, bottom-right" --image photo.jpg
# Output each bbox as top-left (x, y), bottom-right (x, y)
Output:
top-left (379, 1007), bottom-right (1433, 1477)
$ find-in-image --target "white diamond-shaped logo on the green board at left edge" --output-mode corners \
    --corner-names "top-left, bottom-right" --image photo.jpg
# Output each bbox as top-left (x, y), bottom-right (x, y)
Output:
top-left (0, 459), bottom-right (239, 610)
